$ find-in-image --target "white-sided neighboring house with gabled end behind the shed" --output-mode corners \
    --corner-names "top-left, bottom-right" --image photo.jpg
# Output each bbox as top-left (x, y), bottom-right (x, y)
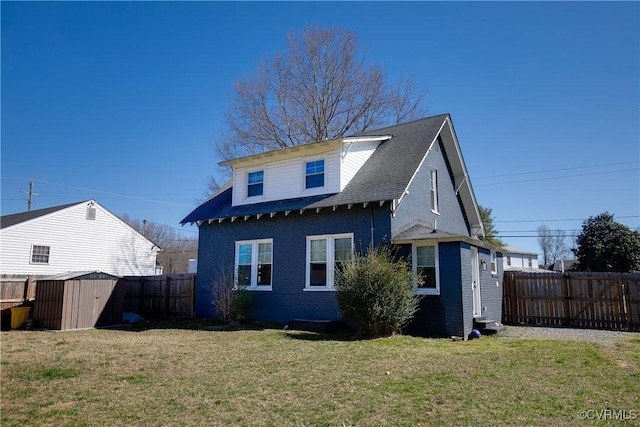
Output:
top-left (0, 200), bottom-right (161, 276)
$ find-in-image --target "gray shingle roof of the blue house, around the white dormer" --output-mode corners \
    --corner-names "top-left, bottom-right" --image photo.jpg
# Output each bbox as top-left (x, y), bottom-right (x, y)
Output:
top-left (180, 114), bottom-right (449, 224)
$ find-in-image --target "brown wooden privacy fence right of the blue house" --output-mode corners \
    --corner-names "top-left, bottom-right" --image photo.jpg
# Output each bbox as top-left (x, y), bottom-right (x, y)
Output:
top-left (504, 272), bottom-right (640, 331)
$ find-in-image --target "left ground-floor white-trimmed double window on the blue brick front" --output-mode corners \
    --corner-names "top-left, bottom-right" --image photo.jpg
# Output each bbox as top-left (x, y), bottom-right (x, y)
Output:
top-left (235, 239), bottom-right (273, 291)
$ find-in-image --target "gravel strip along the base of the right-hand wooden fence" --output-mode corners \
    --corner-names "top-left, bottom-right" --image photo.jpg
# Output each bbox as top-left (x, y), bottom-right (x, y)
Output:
top-left (498, 326), bottom-right (640, 344)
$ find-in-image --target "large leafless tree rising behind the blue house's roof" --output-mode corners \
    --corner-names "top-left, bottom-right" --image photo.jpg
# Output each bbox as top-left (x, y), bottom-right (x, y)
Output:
top-left (216, 27), bottom-right (426, 159)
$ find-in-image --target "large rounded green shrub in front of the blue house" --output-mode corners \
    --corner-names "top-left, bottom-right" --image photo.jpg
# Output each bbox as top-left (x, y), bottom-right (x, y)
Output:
top-left (336, 245), bottom-right (420, 338)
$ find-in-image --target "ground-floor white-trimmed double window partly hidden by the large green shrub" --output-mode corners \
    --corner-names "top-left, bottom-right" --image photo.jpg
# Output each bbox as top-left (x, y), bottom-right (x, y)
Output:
top-left (305, 233), bottom-right (353, 291)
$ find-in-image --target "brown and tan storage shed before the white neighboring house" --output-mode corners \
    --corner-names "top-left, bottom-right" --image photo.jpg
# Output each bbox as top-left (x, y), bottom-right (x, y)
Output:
top-left (32, 271), bottom-right (124, 330)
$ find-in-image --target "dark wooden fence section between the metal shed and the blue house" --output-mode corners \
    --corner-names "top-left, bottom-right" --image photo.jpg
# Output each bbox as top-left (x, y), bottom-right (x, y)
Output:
top-left (118, 274), bottom-right (196, 318)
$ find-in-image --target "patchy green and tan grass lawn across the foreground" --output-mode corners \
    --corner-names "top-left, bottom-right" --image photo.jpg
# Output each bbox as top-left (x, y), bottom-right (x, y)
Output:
top-left (0, 321), bottom-right (640, 426)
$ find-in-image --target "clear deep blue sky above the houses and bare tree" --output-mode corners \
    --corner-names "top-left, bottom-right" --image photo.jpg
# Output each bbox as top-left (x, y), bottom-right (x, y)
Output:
top-left (1, 2), bottom-right (640, 251)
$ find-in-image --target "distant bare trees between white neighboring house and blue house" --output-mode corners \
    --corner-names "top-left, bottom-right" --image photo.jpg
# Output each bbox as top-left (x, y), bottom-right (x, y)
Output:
top-left (121, 214), bottom-right (198, 274)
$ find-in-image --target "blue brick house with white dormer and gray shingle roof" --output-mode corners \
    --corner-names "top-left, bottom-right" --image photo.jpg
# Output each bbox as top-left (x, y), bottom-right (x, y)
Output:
top-left (181, 114), bottom-right (502, 337)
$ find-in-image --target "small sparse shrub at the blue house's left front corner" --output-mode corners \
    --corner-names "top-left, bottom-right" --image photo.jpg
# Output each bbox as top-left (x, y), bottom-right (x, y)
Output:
top-left (211, 271), bottom-right (253, 323)
